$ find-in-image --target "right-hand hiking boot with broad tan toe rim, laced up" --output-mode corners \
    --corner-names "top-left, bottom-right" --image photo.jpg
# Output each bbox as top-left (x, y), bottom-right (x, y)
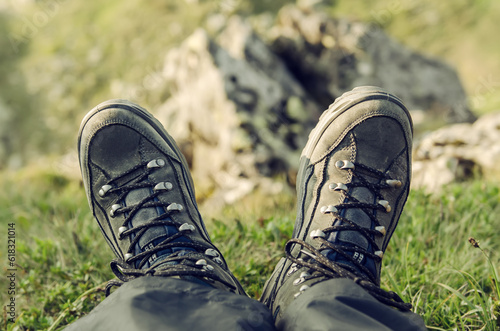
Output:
top-left (261, 87), bottom-right (412, 320)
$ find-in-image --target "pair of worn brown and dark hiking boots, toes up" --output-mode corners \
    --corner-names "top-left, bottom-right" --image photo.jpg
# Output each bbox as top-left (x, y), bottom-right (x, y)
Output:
top-left (78, 87), bottom-right (412, 319)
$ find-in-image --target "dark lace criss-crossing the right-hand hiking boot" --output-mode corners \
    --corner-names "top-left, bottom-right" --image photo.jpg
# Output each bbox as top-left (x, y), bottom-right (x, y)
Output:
top-left (285, 161), bottom-right (412, 311)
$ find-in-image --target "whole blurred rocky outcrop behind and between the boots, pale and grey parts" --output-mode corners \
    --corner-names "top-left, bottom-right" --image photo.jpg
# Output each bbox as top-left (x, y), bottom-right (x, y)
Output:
top-left (150, 7), bottom-right (473, 203)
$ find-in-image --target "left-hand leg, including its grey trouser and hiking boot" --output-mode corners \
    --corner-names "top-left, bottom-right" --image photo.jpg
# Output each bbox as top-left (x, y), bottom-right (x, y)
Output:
top-left (69, 100), bottom-right (274, 330)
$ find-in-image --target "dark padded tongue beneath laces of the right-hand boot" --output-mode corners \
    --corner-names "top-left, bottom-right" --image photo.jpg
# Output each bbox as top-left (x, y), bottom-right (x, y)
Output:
top-left (322, 187), bottom-right (376, 278)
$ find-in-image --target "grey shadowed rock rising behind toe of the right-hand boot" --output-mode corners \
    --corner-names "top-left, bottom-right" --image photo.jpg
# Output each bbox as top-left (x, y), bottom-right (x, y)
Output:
top-left (268, 6), bottom-right (475, 123)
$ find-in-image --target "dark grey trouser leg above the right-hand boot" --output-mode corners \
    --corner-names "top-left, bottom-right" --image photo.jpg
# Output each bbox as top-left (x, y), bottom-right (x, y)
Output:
top-left (276, 278), bottom-right (427, 331)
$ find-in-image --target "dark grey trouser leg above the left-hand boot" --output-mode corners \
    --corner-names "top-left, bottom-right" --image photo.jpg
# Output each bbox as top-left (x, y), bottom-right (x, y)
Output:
top-left (66, 277), bottom-right (275, 331)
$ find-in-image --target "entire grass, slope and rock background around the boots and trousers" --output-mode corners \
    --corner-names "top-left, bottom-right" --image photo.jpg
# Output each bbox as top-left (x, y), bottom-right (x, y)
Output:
top-left (0, 0), bottom-right (500, 330)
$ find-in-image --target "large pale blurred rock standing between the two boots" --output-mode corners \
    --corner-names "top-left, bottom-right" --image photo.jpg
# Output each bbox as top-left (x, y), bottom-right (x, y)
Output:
top-left (155, 18), bottom-right (320, 203)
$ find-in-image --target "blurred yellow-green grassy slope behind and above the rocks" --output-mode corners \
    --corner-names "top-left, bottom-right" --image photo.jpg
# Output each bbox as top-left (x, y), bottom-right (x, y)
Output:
top-left (0, 0), bottom-right (500, 169)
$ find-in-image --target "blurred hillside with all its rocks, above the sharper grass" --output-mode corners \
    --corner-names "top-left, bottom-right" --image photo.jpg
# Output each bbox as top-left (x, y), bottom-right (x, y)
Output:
top-left (0, 0), bottom-right (500, 205)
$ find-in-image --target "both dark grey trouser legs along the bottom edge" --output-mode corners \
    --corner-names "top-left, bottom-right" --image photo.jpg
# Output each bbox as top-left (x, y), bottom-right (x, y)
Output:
top-left (66, 277), bottom-right (426, 331)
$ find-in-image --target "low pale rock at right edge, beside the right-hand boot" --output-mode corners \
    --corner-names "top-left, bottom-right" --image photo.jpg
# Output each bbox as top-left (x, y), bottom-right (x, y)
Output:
top-left (412, 112), bottom-right (500, 192)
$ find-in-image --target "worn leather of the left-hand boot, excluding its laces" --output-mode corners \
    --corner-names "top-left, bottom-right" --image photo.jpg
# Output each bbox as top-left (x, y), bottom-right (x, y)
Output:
top-left (78, 100), bottom-right (245, 295)
